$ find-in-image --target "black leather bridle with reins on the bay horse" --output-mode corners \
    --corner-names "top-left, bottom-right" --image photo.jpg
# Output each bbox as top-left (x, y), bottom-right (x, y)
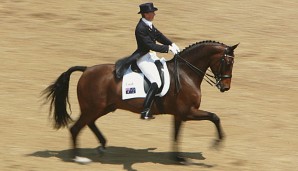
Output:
top-left (174, 48), bottom-right (234, 93)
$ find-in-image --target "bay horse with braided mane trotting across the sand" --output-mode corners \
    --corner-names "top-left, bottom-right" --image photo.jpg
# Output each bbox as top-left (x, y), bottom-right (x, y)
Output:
top-left (42, 40), bottom-right (238, 163)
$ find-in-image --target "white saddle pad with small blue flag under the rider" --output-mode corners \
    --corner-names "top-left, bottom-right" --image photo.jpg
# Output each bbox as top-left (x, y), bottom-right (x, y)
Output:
top-left (122, 58), bottom-right (170, 100)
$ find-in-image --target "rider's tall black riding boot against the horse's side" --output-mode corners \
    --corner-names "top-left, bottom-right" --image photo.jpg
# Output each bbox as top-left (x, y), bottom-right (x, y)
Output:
top-left (141, 83), bottom-right (158, 120)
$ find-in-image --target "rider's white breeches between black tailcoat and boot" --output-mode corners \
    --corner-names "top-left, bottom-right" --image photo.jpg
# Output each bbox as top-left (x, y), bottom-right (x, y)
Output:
top-left (137, 52), bottom-right (161, 88)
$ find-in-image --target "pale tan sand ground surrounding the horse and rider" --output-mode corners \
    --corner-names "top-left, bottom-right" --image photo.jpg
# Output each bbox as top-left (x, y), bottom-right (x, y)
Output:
top-left (0, 0), bottom-right (298, 171)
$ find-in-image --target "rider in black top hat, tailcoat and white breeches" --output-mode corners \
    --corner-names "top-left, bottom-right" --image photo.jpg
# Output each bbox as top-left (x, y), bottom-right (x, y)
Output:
top-left (116, 3), bottom-right (180, 119)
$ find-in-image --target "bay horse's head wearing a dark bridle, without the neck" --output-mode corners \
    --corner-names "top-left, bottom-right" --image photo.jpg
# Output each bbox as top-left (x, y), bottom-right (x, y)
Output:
top-left (210, 43), bottom-right (239, 92)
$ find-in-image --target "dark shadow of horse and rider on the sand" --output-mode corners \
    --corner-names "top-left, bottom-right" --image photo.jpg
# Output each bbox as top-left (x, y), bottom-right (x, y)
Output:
top-left (27, 146), bottom-right (214, 171)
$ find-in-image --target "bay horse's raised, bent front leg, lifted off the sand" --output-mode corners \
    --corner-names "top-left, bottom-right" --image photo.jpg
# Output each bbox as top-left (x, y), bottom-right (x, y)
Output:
top-left (185, 109), bottom-right (224, 145)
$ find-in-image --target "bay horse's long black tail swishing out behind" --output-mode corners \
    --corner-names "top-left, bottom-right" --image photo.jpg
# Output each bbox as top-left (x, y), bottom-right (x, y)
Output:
top-left (42, 66), bottom-right (87, 129)
